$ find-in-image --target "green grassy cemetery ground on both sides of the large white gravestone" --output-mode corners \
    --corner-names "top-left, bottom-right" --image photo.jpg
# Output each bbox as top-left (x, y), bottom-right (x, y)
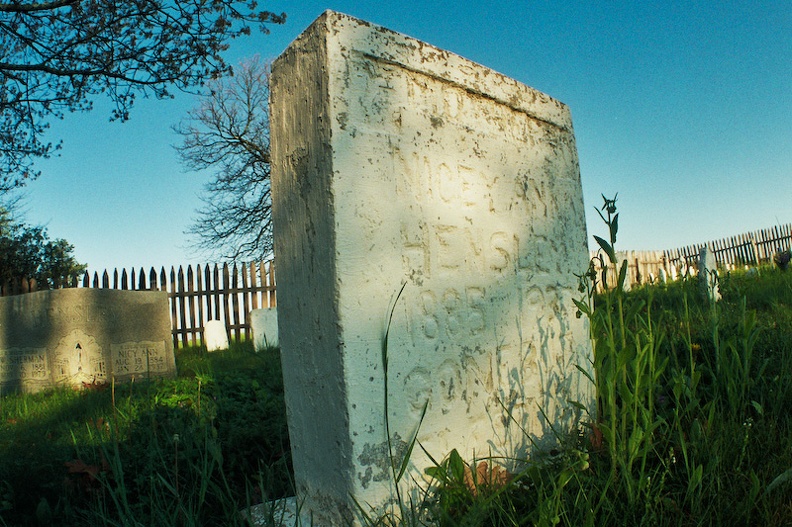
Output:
top-left (0, 267), bottom-right (792, 526)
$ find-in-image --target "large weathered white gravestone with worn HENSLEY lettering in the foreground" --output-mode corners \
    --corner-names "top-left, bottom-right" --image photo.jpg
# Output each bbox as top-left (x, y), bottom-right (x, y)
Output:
top-left (271, 11), bottom-right (593, 525)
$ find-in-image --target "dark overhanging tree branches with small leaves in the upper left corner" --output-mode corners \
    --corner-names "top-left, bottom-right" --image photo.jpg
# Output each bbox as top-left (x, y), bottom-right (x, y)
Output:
top-left (0, 0), bottom-right (285, 191)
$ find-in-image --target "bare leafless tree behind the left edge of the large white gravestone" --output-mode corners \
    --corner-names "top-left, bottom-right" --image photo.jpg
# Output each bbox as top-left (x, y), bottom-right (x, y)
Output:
top-left (175, 58), bottom-right (272, 260)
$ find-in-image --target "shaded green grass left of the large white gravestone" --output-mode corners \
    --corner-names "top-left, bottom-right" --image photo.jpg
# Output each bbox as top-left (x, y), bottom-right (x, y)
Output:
top-left (0, 343), bottom-right (293, 526)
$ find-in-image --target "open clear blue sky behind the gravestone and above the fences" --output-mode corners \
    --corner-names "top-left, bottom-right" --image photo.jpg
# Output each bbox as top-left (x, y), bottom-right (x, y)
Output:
top-left (18, 0), bottom-right (792, 270)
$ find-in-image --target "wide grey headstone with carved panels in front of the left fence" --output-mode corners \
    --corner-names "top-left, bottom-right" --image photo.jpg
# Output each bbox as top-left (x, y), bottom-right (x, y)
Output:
top-left (0, 289), bottom-right (176, 392)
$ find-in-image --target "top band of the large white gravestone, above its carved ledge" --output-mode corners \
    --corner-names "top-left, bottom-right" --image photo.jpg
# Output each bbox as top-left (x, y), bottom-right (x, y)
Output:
top-left (276, 10), bottom-right (572, 132)
